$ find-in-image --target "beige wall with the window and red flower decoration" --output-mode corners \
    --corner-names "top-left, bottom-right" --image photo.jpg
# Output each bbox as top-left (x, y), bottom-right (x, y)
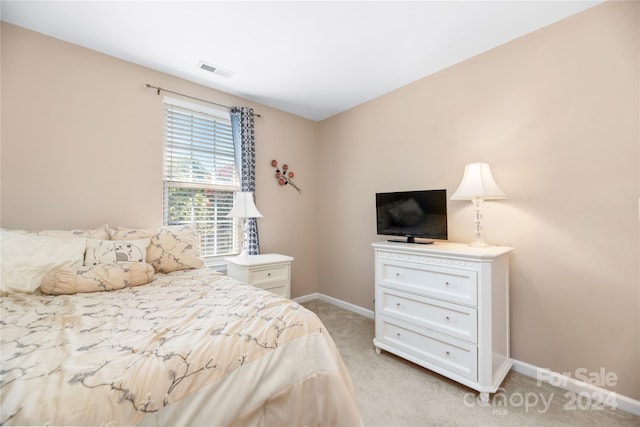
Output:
top-left (0, 23), bottom-right (318, 297)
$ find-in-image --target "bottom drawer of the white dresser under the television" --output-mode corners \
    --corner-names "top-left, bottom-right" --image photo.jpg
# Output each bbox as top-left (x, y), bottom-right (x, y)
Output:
top-left (376, 316), bottom-right (478, 381)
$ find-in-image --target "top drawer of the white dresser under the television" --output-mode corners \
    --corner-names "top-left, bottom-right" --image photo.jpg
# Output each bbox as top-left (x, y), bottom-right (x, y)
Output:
top-left (378, 262), bottom-right (478, 306)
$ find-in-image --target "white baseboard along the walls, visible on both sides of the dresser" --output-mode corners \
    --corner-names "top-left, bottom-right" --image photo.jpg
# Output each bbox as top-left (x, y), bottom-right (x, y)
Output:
top-left (294, 293), bottom-right (640, 416)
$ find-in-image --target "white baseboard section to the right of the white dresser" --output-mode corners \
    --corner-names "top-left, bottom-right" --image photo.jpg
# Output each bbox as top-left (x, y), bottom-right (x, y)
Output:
top-left (511, 360), bottom-right (640, 415)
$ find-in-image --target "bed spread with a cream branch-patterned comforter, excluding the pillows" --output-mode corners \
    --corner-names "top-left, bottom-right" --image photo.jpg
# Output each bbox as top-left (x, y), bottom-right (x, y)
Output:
top-left (0, 226), bottom-right (361, 426)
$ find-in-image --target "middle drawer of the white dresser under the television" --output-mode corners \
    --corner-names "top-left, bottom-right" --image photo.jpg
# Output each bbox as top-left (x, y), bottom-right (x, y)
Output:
top-left (376, 286), bottom-right (478, 344)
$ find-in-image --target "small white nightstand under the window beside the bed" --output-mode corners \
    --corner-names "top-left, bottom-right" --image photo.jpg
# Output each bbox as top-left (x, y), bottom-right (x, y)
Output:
top-left (224, 254), bottom-right (293, 298)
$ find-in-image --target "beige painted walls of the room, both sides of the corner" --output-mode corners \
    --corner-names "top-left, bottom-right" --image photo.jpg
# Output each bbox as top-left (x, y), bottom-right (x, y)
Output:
top-left (0, 2), bottom-right (640, 399)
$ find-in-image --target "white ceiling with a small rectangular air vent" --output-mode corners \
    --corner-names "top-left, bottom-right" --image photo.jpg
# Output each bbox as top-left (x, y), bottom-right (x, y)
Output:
top-left (0, 0), bottom-right (601, 120)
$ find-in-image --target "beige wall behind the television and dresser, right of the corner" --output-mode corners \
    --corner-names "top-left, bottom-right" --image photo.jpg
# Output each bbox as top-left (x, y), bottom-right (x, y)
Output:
top-left (318, 2), bottom-right (640, 399)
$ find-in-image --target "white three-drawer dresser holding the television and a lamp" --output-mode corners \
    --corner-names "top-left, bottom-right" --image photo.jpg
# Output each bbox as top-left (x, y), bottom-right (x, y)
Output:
top-left (372, 242), bottom-right (512, 401)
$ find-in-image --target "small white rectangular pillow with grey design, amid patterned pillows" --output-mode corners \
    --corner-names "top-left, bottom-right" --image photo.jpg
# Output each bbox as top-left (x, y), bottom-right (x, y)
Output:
top-left (84, 239), bottom-right (151, 265)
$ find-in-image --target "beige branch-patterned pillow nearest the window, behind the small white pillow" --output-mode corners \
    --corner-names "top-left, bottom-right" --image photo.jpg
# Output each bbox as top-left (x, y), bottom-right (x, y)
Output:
top-left (110, 224), bottom-right (204, 273)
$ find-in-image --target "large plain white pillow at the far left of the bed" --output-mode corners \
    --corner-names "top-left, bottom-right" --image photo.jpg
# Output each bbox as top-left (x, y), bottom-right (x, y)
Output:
top-left (0, 229), bottom-right (86, 292)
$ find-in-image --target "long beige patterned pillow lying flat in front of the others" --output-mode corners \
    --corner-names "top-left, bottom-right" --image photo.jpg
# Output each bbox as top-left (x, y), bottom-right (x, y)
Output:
top-left (40, 262), bottom-right (153, 295)
